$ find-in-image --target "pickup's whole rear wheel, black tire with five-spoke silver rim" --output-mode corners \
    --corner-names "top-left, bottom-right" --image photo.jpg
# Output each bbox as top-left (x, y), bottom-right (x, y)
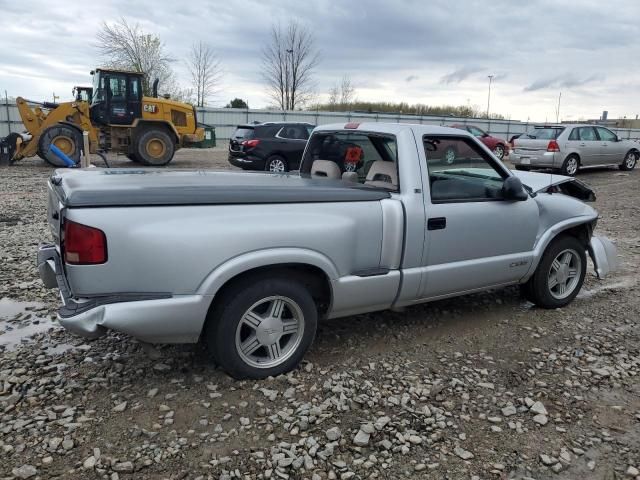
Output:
top-left (205, 277), bottom-right (318, 379)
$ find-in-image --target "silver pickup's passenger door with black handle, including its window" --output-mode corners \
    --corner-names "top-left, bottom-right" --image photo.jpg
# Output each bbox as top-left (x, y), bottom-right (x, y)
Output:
top-left (418, 135), bottom-right (538, 299)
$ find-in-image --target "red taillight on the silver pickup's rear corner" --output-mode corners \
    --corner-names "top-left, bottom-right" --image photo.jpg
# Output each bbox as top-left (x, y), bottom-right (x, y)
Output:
top-left (63, 220), bottom-right (107, 265)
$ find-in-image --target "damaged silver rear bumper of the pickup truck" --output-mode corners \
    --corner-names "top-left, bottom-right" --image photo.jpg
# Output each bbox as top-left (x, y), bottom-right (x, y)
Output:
top-left (37, 245), bottom-right (211, 343)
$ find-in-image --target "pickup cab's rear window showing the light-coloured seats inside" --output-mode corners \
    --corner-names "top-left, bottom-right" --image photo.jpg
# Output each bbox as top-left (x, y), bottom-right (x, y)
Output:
top-left (300, 131), bottom-right (399, 191)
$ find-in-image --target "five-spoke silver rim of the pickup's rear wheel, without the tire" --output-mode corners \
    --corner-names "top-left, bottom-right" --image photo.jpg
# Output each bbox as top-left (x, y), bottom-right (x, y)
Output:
top-left (236, 295), bottom-right (304, 368)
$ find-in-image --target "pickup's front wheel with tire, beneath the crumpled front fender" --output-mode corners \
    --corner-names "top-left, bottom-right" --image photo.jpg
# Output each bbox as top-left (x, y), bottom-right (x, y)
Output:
top-left (522, 235), bottom-right (587, 308)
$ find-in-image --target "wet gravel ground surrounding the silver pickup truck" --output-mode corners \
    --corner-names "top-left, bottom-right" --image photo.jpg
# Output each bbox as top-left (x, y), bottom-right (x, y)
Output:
top-left (0, 149), bottom-right (640, 480)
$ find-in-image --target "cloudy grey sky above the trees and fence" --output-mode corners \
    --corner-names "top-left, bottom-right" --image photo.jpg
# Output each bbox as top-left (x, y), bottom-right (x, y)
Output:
top-left (0, 0), bottom-right (640, 122)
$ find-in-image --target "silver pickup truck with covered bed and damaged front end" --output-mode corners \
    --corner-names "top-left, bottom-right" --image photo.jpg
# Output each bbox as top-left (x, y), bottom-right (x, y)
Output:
top-left (38, 123), bottom-right (616, 378)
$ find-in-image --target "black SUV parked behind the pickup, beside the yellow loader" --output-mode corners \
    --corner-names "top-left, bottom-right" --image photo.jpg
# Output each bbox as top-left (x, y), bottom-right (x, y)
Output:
top-left (229, 122), bottom-right (314, 172)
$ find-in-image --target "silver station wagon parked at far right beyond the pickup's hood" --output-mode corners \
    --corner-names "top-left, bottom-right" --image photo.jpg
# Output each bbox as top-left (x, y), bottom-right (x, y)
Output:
top-left (509, 124), bottom-right (640, 176)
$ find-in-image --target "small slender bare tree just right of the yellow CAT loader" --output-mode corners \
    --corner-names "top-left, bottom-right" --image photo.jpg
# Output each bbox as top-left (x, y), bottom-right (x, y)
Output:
top-left (187, 41), bottom-right (222, 107)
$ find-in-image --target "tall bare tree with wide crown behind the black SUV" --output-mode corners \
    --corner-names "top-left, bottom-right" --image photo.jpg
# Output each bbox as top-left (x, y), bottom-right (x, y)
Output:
top-left (262, 20), bottom-right (320, 110)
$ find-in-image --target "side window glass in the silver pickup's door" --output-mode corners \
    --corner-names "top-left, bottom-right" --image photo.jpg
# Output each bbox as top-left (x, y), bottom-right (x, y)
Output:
top-left (423, 135), bottom-right (507, 203)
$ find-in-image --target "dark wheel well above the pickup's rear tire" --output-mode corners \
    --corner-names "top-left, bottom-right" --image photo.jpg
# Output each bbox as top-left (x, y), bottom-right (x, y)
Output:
top-left (208, 263), bottom-right (331, 322)
